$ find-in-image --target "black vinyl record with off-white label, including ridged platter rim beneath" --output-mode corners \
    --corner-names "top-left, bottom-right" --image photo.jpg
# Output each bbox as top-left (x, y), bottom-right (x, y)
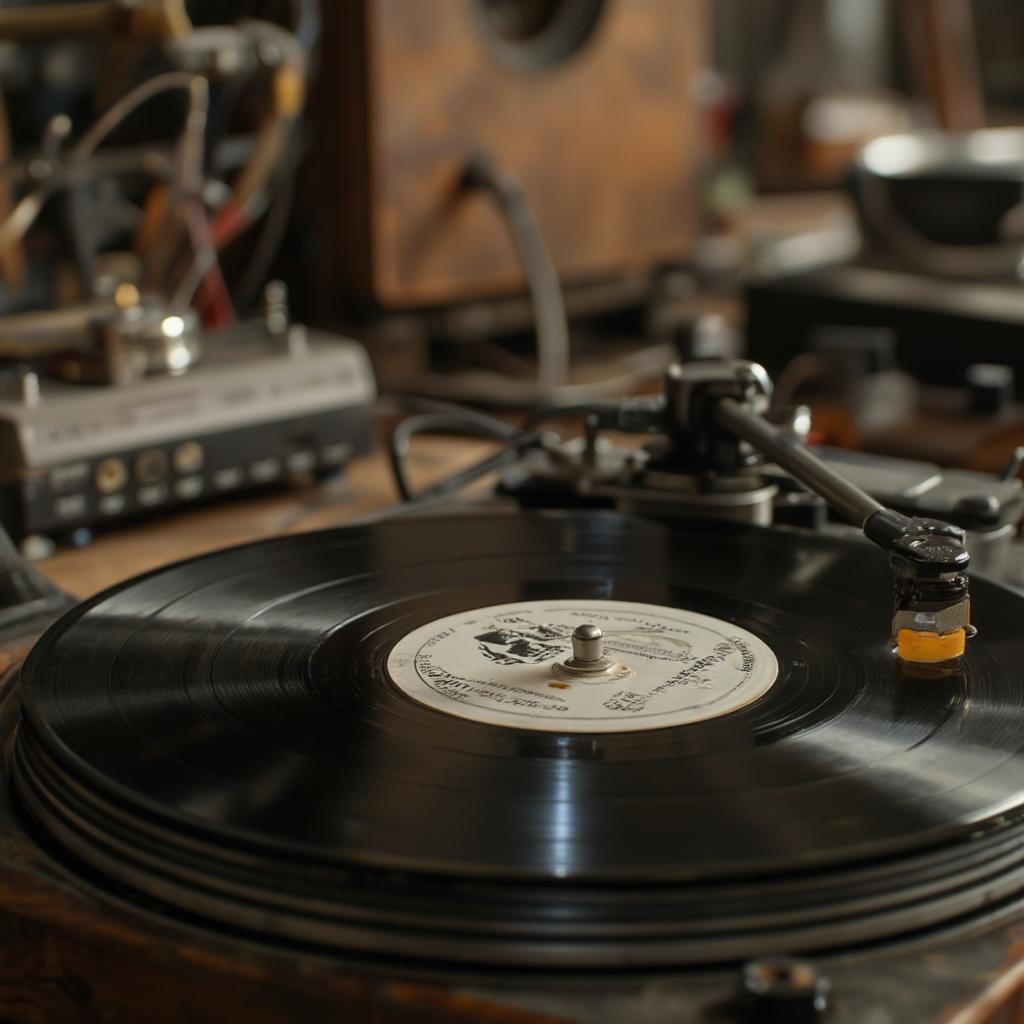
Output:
top-left (15, 513), bottom-right (1024, 969)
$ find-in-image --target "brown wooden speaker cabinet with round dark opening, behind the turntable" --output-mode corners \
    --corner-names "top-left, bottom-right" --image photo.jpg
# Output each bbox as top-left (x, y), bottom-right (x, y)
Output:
top-left (309, 0), bottom-right (706, 309)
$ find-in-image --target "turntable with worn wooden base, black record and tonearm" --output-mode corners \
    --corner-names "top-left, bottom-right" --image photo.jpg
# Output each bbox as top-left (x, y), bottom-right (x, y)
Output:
top-left (0, 362), bottom-right (1024, 1024)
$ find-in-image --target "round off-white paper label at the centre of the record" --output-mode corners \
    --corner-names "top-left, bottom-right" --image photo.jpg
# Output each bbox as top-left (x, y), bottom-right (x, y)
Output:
top-left (387, 599), bottom-right (778, 732)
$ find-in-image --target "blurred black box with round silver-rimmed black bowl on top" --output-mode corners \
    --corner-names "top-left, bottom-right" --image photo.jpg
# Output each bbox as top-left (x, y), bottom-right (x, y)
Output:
top-left (748, 128), bottom-right (1024, 399)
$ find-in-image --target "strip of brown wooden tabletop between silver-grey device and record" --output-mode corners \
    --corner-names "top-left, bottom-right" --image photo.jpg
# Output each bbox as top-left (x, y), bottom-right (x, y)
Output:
top-left (36, 437), bottom-right (492, 598)
